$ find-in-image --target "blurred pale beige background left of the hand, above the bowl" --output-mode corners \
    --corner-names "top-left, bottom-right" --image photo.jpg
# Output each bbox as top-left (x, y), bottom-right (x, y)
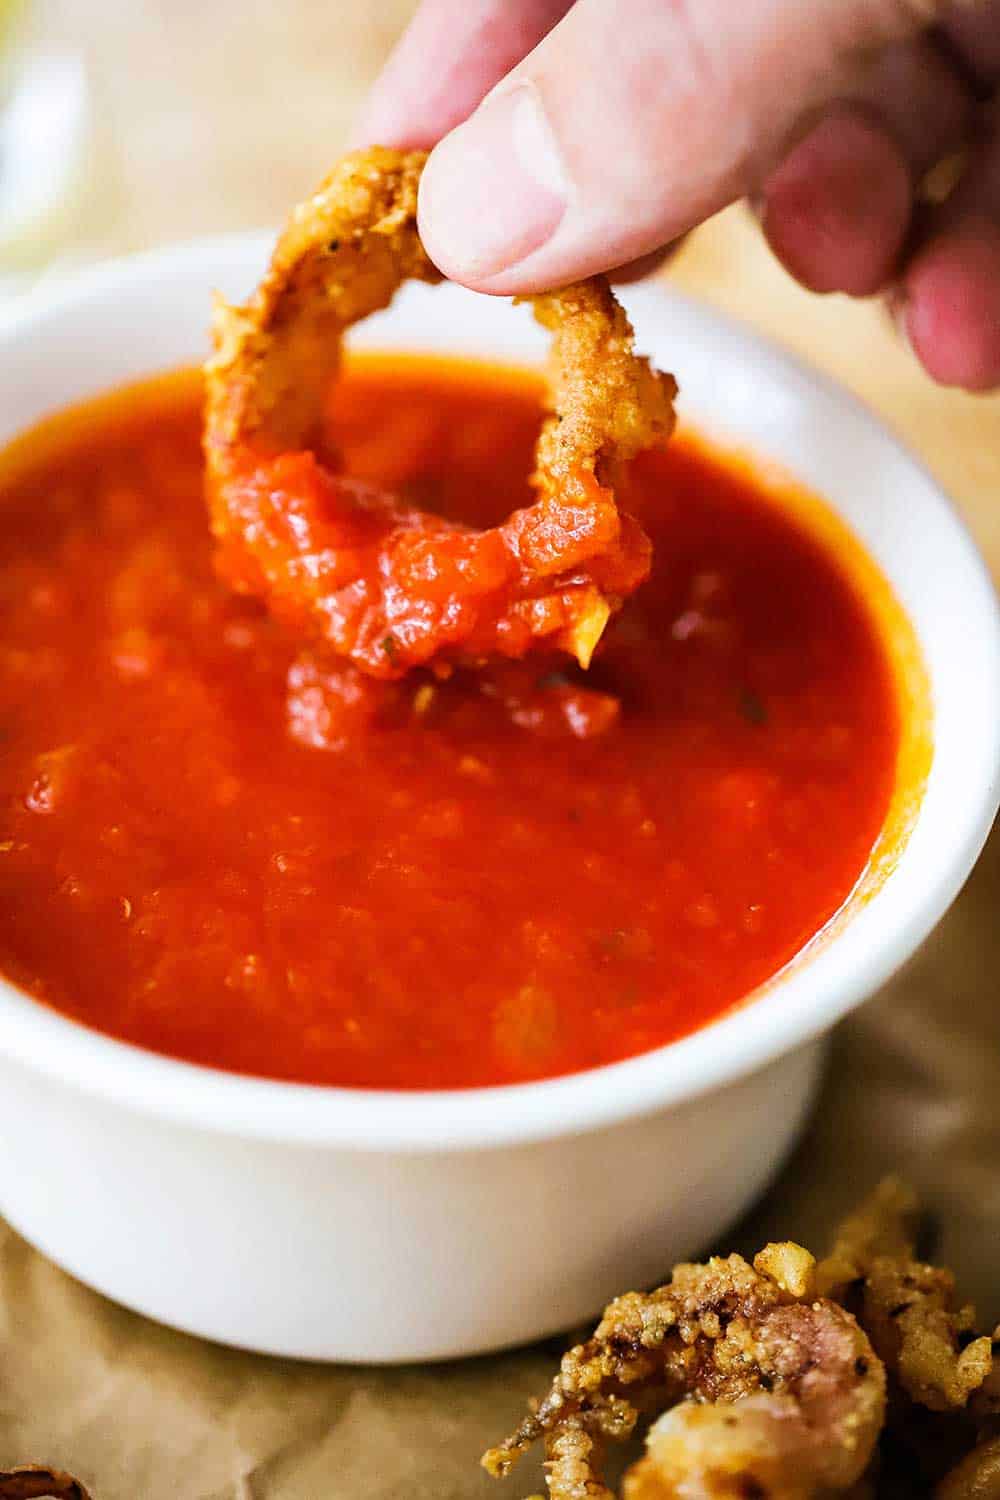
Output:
top-left (0, 0), bottom-right (414, 264)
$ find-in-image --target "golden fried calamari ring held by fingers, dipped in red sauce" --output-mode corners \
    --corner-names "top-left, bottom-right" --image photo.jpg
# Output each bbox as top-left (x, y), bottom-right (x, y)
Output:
top-left (205, 149), bottom-right (676, 678)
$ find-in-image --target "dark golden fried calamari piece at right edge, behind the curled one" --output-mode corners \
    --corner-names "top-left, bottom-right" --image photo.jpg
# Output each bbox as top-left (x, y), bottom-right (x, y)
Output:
top-left (816, 1178), bottom-right (993, 1412)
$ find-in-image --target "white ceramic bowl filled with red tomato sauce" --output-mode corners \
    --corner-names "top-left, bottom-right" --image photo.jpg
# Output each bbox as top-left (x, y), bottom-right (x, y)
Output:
top-left (0, 236), bottom-right (1000, 1361)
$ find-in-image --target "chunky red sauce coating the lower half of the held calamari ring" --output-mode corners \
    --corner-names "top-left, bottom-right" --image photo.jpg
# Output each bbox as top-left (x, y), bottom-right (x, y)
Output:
top-left (213, 452), bottom-right (649, 680)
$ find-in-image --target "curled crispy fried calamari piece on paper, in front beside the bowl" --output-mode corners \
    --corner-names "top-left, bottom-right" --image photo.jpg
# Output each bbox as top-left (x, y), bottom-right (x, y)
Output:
top-left (483, 1245), bottom-right (885, 1500)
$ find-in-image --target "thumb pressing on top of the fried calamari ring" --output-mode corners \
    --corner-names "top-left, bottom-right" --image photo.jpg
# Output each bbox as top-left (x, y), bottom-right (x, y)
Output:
top-left (420, 0), bottom-right (943, 294)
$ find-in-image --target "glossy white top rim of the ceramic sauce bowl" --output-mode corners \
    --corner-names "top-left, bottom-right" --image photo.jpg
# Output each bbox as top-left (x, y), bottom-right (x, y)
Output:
top-left (0, 231), bottom-right (1000, 1152)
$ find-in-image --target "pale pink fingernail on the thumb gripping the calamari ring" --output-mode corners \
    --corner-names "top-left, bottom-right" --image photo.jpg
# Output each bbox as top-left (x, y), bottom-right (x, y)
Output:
top-left (420, 84), bottom-right (570, 281)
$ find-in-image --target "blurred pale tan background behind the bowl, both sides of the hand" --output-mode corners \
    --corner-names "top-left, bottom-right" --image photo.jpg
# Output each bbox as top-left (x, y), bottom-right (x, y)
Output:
top-left (0, 0), bottom-right (1000, 570)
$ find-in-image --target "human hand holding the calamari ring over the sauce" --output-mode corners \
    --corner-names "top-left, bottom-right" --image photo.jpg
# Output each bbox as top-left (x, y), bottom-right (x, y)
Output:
top-left (358, 0), bottom-right (1000, 390)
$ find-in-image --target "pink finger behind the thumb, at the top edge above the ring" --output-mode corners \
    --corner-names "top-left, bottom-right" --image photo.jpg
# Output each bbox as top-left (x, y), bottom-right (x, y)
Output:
top-left (351, 0), bottom-right (573, 150)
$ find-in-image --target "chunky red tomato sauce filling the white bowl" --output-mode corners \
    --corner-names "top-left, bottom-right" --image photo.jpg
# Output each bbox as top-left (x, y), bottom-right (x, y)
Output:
top-left (0, 357), bottom-right (900, 1089)
